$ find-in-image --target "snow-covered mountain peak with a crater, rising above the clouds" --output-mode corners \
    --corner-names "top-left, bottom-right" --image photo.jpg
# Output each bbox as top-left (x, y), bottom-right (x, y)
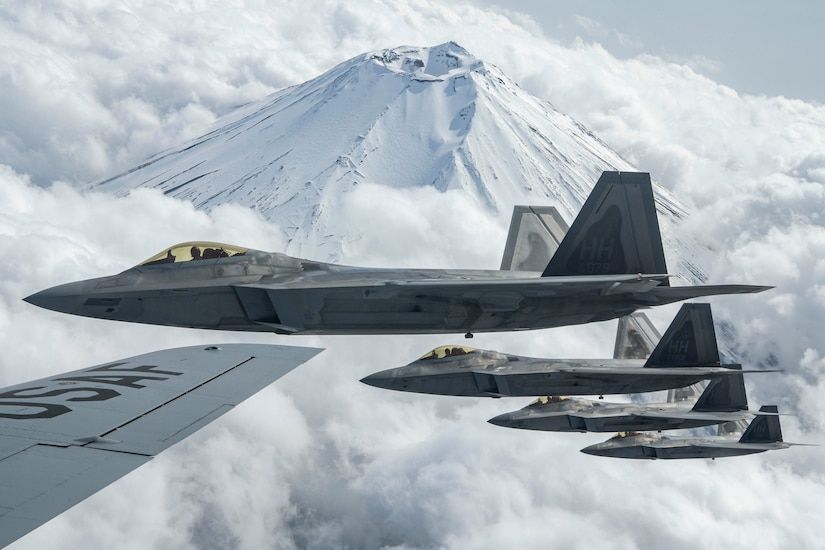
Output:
top-left (91, 42), bottom-right (704, 281)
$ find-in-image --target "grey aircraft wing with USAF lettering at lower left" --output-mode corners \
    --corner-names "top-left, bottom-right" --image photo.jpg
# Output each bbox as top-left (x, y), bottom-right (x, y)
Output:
top-left (0, 344), bottom-right (321, 547)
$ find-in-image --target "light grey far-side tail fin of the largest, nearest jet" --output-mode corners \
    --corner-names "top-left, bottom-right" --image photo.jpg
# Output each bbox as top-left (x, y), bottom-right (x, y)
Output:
top-left (501, 206), bottom-right (567, 272)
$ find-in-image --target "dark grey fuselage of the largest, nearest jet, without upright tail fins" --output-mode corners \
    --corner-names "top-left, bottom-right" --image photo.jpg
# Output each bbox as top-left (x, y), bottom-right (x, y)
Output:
top-left (26, 250), bottom-right (763, 334)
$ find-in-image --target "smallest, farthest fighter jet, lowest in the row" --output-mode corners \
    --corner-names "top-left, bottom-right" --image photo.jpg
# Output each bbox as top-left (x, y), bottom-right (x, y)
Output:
top-left (581, 405), bottom-right (800, 459)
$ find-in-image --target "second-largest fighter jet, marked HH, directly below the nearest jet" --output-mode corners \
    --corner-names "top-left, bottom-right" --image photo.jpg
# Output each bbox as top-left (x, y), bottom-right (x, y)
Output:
top-left (361, 304), bottom-right (767, 397)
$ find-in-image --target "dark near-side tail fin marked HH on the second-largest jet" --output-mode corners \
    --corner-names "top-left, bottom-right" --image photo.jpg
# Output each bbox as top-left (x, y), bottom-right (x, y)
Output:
top-left (645, 304), bottom-right (719, 367)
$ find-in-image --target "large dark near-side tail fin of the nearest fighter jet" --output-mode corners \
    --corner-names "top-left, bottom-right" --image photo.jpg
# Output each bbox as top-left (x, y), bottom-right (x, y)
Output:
top-left (542, 172), bottom-right (669, 286)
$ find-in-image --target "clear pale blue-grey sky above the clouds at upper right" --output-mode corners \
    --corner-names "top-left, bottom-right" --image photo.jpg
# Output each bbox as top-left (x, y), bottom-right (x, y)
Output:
top-left (477, 0), bottom-right (825, 104)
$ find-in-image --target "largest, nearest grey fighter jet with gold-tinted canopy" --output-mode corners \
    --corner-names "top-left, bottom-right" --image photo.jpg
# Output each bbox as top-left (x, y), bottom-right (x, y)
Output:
top-left (26, 172), bottom-right (770, 337)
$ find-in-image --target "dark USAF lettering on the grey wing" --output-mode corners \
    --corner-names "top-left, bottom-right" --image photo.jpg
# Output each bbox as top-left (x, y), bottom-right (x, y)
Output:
top-left (0, 362), bottom-right (184, 420)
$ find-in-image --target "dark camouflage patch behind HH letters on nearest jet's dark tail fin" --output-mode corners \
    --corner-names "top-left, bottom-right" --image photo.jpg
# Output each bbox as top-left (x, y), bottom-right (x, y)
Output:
top-left (567, 205), bottom-right (627, 275)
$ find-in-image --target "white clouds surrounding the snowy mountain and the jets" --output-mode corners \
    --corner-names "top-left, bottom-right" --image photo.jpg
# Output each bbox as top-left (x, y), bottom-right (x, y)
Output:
top-left (0, 0), bottom-right (825, 549)
